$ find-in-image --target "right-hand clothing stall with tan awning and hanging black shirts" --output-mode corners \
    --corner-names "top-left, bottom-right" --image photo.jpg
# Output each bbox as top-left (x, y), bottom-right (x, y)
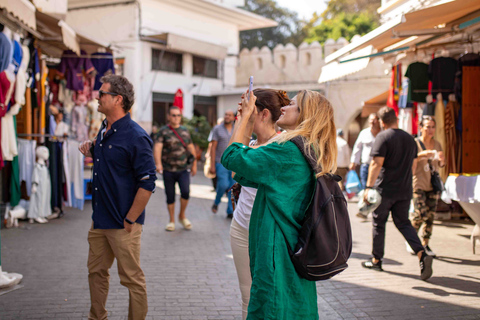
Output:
top-left (324, 0), bottom-right (480, 250)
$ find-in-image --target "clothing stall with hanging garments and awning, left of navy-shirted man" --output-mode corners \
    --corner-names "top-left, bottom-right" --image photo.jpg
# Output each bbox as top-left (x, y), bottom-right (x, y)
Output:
top-left (0, 0), bottom-right (115, 223)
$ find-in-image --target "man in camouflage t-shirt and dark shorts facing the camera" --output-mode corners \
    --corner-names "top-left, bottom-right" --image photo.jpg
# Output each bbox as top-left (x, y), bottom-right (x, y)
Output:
top-left (154, 107), bottom-right (197, 231)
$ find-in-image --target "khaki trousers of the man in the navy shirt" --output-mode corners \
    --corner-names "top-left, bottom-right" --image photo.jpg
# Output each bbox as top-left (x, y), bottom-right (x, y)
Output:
top-left (87, 223), bottom-right (148, 320)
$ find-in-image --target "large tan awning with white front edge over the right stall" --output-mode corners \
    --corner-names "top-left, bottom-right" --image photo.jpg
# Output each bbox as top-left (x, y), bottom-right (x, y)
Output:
top-left (325, 0), bottom-right (480, 63)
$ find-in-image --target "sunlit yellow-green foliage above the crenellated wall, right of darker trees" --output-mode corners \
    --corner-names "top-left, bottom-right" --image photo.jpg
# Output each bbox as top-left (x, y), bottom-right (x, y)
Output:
top-left (305, 11), bottom-right (379, 44)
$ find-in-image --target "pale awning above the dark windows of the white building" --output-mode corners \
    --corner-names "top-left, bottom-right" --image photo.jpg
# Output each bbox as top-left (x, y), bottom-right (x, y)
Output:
top-left (141, 33), bottom-right (227, 60)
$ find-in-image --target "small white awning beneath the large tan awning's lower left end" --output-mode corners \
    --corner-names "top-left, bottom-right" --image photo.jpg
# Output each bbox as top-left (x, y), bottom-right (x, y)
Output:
top-left (318, 46), bottom-right (373, 83)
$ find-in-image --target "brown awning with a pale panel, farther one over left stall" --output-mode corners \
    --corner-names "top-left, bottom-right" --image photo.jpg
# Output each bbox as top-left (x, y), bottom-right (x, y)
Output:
top-left (36, 11), bottom-right (108, 57)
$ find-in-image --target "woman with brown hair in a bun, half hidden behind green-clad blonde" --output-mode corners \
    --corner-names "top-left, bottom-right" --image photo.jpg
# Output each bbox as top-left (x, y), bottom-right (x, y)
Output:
top-left (230, 89), bottom-right (290, 320)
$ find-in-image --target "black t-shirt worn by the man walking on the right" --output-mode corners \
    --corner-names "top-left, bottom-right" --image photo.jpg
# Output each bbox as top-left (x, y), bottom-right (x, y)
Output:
top-left (371, 129), bottom-right (418, 199)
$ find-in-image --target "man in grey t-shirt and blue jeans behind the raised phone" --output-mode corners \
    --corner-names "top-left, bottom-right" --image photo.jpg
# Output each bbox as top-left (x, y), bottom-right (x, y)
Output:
top-left (210, 110), bottom-right (235, 218)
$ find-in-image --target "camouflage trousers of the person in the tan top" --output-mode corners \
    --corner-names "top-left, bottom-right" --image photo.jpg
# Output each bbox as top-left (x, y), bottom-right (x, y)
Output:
top-left (410, 189), bottom-right (439, 239)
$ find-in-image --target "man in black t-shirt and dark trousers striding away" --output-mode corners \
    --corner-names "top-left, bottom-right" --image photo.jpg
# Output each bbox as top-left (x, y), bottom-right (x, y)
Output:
top-left (362, 107), bottom-right (433, 280)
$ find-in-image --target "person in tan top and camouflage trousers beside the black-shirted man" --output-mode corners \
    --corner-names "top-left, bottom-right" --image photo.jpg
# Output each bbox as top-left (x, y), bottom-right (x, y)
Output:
top-left (407, 116), bottom-right (445, 257)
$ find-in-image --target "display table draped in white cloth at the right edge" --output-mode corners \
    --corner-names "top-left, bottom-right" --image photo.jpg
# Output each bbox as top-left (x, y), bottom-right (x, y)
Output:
top-left (442, 174), bottom-right (480, 254)
